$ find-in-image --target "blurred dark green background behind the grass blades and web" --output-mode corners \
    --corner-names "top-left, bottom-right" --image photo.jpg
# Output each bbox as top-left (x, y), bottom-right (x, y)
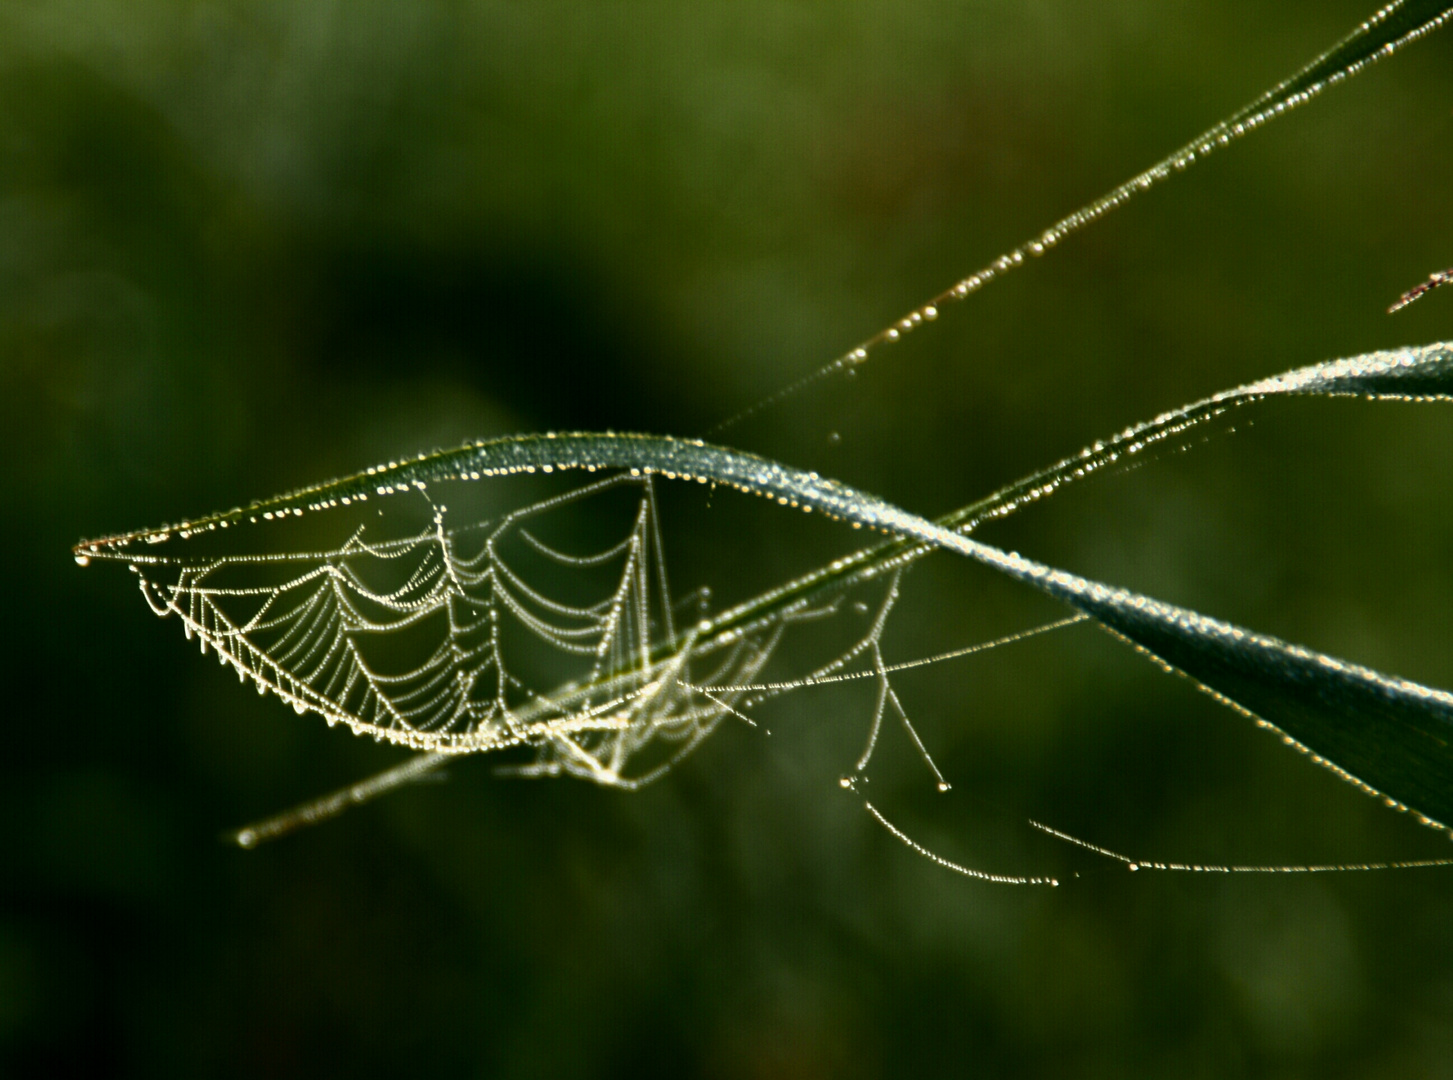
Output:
top-left (8, 0), bottom-right (1453, 1077)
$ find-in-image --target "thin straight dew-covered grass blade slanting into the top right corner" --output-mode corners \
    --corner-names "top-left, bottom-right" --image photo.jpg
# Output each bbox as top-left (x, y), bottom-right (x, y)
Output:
top-left (709, 0), bottom-right (1453, 435)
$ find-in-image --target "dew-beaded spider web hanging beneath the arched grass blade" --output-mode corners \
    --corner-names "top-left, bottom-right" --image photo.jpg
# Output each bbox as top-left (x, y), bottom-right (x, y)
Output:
top-left (118, 474), bottom-right (947, 789)
